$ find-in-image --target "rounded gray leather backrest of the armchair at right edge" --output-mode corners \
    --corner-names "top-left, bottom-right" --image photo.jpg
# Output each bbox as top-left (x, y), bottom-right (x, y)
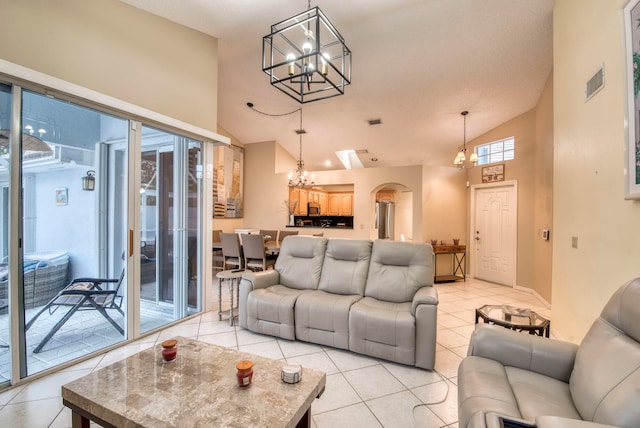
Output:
top-left (569, 278), bottom-right (640, 428)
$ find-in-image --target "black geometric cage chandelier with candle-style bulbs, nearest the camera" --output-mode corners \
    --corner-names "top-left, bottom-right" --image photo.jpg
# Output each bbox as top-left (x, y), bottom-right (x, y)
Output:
top-left (262, 1), bottom-right (351, 104)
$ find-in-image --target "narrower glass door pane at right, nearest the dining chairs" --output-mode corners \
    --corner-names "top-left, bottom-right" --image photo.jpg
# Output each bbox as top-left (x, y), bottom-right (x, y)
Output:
top-left (140, 126), bottom-right (203, 333)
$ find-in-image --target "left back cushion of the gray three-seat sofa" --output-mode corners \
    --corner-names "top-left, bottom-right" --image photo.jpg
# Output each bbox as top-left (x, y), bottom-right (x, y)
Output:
top-left (275, 236), bottom-right (327, 290)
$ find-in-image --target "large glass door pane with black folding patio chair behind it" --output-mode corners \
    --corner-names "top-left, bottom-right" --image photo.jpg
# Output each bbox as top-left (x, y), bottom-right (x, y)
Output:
top-left (21, 91), bottom-right (128, 376)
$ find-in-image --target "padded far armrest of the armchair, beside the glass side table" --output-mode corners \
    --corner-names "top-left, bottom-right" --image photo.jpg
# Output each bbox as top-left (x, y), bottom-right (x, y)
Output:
top-left (468, 324), bottom-right (578, 382)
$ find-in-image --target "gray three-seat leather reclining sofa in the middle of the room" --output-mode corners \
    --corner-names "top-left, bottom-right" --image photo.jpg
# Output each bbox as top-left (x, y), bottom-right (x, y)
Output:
top-left (238, 236), bottom-right (438, 370)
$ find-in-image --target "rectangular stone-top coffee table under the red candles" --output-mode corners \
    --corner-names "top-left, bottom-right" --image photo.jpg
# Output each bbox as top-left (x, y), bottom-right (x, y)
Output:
top-left (62, 337), bottom-right (326, 428)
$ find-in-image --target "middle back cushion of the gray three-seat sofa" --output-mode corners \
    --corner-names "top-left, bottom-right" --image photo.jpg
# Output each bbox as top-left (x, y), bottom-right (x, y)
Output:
top-left (318, 239), bottom-right (372, 296)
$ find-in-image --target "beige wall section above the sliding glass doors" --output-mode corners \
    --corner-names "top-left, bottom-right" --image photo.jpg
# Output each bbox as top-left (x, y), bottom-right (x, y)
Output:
top-left (0, 0), bottom-right (218, 132)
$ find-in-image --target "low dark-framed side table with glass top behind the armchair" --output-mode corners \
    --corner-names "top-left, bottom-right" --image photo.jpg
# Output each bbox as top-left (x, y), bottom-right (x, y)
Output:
top-left (476, 305), bottom-right (551, 337)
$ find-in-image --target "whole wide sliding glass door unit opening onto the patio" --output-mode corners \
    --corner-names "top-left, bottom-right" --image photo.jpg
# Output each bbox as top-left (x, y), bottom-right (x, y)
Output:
top-left (0, 78), bottom-right (209, 389)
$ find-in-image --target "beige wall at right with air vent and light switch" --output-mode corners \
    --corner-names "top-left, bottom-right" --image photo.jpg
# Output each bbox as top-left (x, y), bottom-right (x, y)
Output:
top-left (552, 0), bottom-right (640, 342)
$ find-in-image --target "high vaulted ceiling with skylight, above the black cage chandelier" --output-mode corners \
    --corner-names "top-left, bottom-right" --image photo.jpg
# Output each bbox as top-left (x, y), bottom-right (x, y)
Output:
top-left (122, 0), bottom-right (554, 170)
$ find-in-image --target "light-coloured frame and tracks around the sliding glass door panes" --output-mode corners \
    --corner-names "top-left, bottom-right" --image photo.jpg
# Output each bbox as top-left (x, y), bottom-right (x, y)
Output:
top-left (0, 69), bottom-right (222, 390)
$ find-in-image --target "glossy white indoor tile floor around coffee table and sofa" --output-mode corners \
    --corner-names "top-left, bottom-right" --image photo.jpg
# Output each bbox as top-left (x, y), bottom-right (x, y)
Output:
top-left (0, 280), bottom-right (550, 428)
